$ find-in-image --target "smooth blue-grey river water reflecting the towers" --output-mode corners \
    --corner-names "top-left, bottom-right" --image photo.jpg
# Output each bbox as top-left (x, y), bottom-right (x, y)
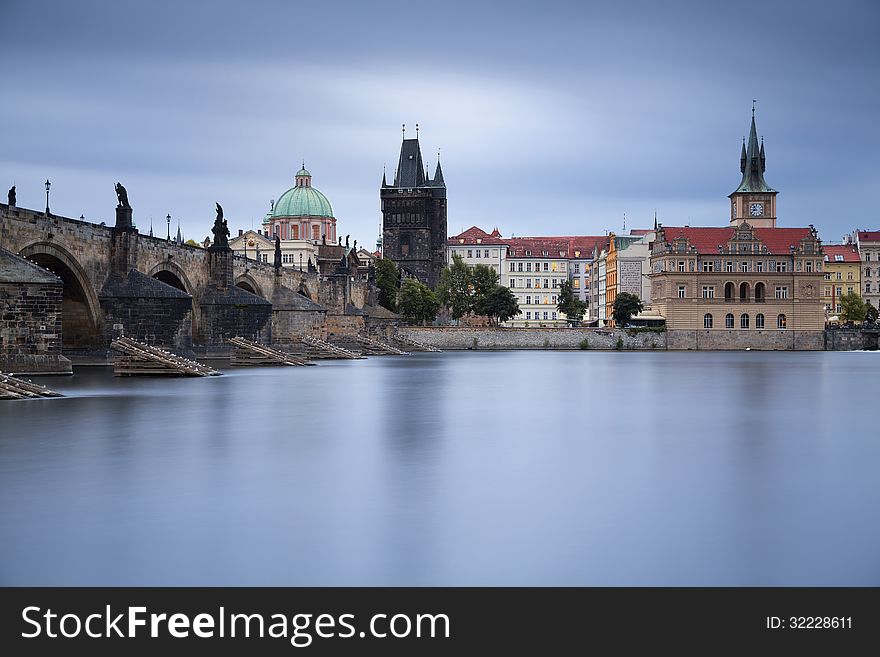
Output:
top-left (0, 351), bottom-right (880, 586)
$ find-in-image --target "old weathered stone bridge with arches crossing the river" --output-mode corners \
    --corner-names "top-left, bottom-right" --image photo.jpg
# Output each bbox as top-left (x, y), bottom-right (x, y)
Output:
top-left (0, 203), bottom-right (371, 363)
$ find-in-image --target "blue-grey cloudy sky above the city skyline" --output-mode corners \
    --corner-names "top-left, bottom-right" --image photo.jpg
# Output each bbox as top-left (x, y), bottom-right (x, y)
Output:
top-left (0, 0), bottom-right (880, 245)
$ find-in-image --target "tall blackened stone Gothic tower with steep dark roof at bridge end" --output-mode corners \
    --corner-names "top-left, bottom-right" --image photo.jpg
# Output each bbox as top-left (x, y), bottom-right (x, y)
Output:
top-left (379, 133), bottom-right (447, 288)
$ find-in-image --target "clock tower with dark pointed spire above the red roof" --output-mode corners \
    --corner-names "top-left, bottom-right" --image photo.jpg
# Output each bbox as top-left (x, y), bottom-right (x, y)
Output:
top-left (729, 105), bottom-right (779, 228)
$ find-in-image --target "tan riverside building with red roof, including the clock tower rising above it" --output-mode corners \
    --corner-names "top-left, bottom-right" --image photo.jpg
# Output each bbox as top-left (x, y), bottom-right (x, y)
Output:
top-left (650, 112), bottom-right (824, 348)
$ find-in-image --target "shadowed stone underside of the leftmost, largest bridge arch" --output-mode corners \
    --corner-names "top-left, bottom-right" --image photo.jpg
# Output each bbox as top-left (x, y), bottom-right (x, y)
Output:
top-left (19, 242), bottom-right (101, 349)
